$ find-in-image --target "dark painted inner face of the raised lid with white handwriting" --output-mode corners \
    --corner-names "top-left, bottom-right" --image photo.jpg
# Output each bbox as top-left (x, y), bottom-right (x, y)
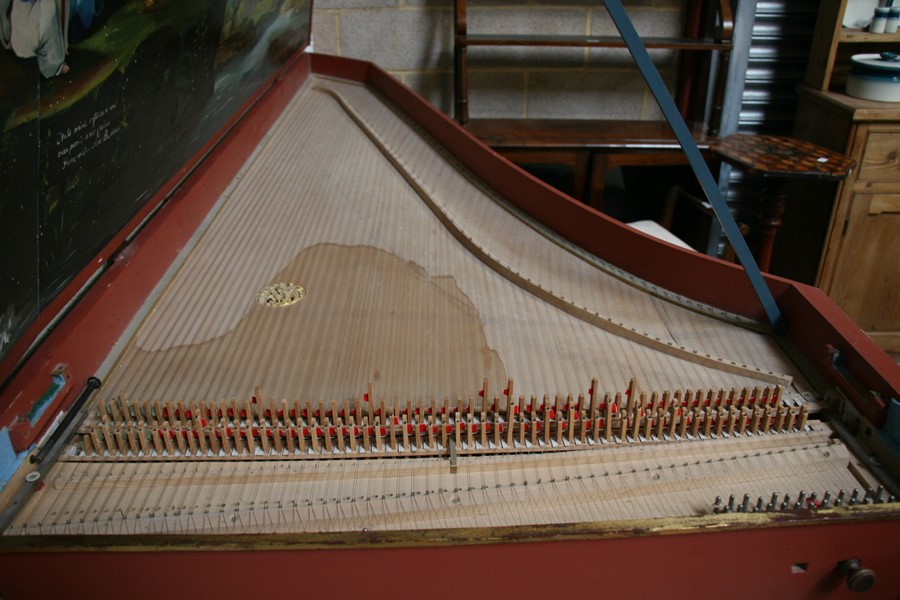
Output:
top-left (0, 0), bottom-right (311, 376)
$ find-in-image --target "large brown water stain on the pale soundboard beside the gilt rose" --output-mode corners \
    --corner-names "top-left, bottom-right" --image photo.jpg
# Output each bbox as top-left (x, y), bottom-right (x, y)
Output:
top-left (105, 244), bottom-right (507, 402)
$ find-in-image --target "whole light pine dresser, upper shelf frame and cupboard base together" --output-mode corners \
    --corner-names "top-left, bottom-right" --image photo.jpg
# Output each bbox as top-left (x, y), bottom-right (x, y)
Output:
top-left (794, 0), bottom-right (900, 352)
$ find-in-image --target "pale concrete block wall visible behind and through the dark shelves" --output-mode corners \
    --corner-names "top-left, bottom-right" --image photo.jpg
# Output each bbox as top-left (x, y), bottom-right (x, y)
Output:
top-left (313, 0), bottom-right (686, 119)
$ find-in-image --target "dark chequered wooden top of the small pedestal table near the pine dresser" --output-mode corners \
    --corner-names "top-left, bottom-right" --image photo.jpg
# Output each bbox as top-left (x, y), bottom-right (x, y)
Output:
top-left (711, 133), bottom-right (856, 179)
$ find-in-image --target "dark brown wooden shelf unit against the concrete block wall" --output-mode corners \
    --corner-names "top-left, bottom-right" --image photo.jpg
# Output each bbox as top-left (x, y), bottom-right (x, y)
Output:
top-left (454, 0), bottom-right (734, 207)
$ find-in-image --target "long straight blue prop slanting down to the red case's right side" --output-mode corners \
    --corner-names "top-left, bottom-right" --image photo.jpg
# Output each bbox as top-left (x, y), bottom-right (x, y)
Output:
top-left (603, 0), bottom-right (787, 334)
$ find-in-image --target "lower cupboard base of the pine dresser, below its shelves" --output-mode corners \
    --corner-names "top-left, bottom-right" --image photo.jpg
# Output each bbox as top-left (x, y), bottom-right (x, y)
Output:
top-left (795, 87), bottom-right (900, 352)
